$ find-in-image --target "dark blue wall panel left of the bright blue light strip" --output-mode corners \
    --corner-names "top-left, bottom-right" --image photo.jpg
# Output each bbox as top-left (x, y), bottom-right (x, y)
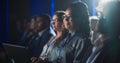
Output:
top-left (29, 0), bottom-right (52, 16)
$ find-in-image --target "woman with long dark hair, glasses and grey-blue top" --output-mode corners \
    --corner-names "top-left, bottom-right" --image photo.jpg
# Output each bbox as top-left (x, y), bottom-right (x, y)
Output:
top-left (58, 2), bottom-right (91, 63)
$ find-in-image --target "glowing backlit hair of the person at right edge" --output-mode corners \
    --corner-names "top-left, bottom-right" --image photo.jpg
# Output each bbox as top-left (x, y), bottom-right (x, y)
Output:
top-left (98, 1), bottom-right (120, 36)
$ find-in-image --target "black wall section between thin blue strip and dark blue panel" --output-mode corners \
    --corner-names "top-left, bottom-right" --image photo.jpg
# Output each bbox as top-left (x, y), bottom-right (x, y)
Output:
top-left (8, 0), bottom-right (29, 43)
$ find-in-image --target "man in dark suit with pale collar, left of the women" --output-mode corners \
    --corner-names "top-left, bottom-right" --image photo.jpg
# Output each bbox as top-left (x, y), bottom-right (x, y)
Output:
top-left (28, 14), bottom-right (52, 58)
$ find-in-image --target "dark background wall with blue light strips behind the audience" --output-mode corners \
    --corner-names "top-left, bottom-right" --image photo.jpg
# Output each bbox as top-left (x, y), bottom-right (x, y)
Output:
top-left (0, 0), bottom-right (97, 44)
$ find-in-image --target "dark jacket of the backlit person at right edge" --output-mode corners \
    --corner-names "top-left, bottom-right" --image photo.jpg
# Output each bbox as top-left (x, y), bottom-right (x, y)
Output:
top-left (93, 38), bottom-right (120, 63)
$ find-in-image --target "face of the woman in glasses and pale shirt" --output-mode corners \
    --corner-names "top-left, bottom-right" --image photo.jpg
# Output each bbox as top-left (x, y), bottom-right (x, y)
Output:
top-left (51, 15), bottom-right (63, 31)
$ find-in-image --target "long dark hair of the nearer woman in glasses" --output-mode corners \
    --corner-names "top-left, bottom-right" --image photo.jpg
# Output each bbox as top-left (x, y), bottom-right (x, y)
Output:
top-left (68, 2), bottom-right (90, 37)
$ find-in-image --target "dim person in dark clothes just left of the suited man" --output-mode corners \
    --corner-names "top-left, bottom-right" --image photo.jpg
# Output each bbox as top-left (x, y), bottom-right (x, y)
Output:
top-left (18, 16), bottom-right (37, 47)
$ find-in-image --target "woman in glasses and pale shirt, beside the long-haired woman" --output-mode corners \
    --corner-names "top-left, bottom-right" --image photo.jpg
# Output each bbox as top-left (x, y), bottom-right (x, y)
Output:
top-left (33, 11), bottom-right (67, 63)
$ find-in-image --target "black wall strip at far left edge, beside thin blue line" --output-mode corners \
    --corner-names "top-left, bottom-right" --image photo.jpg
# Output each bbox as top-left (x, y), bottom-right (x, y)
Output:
top-left (0, 0), bottom-right (6, 45)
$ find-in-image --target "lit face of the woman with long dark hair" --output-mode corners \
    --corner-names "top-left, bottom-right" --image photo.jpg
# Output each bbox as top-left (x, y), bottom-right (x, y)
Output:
top-left (63, 9), bottom-right (73, 30)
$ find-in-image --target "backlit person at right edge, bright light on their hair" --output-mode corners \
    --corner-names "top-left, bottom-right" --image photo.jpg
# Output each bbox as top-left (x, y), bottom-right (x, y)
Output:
top-left (86, 0), bottom-right (120, 63)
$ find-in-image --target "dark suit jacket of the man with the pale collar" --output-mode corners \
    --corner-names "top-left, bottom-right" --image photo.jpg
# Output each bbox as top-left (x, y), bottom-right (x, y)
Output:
top-left (28, 29), bottom-right (52, 58)
